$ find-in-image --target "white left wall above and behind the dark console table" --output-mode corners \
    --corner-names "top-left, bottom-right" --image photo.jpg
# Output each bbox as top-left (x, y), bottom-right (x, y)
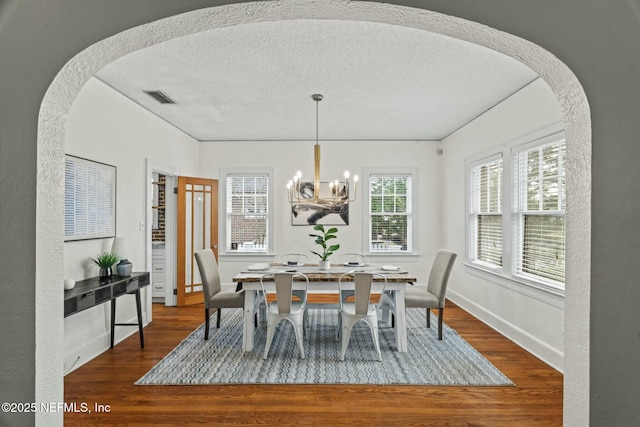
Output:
top-left (64, 78), bottom-right (198, 371)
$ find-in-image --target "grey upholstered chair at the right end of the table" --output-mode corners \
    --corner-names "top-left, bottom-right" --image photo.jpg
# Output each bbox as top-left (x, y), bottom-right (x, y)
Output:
top-left (404, 249), bottom-right (457, 340)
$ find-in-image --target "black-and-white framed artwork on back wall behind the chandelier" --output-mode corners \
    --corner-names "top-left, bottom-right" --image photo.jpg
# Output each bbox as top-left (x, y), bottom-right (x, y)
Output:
top-left (291, 182), bottom-right (349, 225)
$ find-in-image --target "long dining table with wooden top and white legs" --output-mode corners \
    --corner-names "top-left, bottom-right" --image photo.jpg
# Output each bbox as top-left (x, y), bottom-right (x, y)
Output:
top-left (233, 264), bottom-right (417, 352)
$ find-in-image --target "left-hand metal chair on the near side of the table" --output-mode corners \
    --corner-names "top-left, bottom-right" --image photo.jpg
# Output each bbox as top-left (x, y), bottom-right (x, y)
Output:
top-left (260, 272), bottom-right (309, 359)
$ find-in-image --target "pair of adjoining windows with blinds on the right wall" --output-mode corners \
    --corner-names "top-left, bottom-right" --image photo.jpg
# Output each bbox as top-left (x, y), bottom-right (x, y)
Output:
top-left (467, 129), bottom-right (565, 293)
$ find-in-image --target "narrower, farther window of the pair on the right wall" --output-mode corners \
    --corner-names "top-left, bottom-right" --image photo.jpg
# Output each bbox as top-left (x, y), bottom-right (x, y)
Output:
top-left (468, 156), bottom-right (503, 268)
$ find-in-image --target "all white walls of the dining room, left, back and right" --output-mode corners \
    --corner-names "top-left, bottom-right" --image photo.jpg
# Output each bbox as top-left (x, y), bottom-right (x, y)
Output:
top-left (64, 79), bottom-right (564, 370)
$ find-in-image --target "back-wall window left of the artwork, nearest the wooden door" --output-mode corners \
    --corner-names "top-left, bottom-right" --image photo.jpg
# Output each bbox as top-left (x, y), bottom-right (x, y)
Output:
top-left (225, 173), bottom-right (271, 253)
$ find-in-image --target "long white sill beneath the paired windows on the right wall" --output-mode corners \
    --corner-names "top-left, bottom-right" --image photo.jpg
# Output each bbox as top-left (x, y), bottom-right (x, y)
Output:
top-left (464, 262), bottom-right (564, 308)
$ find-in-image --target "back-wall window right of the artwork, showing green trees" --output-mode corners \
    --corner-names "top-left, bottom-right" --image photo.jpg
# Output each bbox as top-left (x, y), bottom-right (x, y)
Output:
top-left (368, 173), bottom-right (413, 253)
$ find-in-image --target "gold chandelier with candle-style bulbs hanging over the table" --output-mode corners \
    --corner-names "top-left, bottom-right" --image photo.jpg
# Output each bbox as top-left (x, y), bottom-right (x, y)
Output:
top-left (287, 93), bottom-right (358, 205)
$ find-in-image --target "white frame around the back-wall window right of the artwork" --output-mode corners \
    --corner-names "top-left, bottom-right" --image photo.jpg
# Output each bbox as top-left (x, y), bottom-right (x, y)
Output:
top-left (363, 167), bottom-right (419, 257)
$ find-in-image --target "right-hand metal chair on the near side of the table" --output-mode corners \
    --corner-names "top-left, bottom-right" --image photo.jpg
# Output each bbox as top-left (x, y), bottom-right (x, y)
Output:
top-left (336, 272), bottom-right (387, 361)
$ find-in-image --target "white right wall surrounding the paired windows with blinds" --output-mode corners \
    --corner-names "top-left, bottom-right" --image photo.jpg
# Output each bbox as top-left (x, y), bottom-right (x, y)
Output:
top-left (443, 79), bottom-right (564, 371)
